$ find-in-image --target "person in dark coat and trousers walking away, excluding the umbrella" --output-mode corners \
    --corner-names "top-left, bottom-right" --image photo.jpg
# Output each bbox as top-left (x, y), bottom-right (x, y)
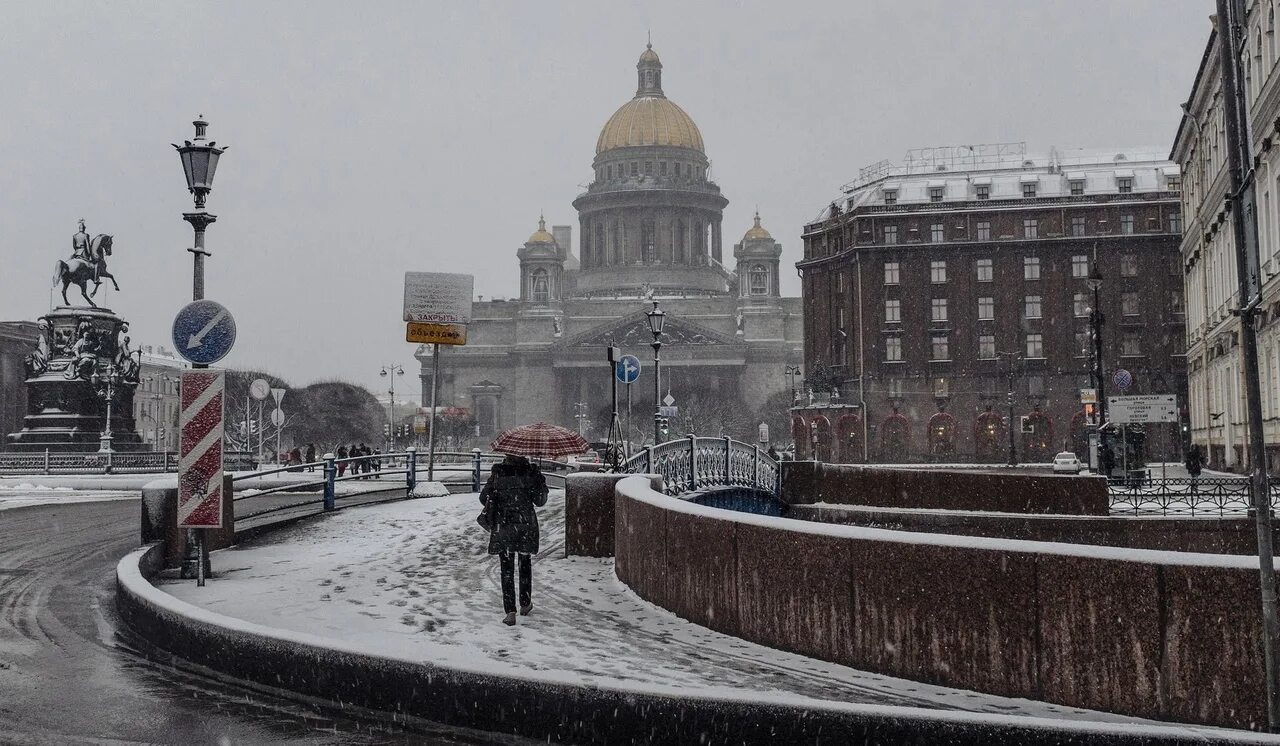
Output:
top-left (480, 454), bottom-right (547, 624)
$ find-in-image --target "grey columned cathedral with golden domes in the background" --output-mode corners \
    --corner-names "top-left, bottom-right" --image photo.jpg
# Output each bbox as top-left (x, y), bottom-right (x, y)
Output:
top-left (417, 46), bottom-right (804, 440)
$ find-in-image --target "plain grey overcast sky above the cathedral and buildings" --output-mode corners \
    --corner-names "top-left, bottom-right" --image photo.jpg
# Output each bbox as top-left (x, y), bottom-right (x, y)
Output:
top-left (0, 0), bottom-right (1213, 389)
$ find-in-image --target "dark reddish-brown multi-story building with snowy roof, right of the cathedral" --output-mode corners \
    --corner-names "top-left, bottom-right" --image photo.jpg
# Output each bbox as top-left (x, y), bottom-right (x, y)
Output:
top-left (792, 143), bottom-right (1185, 461)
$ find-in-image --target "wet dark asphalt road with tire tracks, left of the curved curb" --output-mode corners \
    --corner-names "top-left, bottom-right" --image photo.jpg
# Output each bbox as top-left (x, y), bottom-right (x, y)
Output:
top-left (0, 500), bottom-right (524, 745)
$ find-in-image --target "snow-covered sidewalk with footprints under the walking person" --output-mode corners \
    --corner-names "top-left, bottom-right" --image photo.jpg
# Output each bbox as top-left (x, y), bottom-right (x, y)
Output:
top-left (156, 491), bottom-right (1254, 734)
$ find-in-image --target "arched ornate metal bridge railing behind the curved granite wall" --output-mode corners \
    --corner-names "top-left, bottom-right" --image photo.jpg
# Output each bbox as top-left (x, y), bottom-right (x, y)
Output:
top-left (622, 435), bottom-right (778, 495)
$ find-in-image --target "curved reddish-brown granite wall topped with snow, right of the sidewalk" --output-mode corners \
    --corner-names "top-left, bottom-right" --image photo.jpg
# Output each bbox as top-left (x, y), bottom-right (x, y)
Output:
top-left (614, 477), bottom-right (1266, 728)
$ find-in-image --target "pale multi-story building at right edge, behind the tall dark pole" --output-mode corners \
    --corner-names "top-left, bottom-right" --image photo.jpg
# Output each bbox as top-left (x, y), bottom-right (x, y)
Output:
top-left (1170, 7), bottom-right (1280, 473)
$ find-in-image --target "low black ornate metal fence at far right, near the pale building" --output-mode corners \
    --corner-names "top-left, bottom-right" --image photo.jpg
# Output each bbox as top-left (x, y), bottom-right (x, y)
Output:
top-left (1107, 477), bottom-right (1280, 516)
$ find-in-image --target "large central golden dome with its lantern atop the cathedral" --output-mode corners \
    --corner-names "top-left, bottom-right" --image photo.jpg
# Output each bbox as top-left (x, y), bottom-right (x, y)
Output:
top-left (595, 46), bottom-right (707, 155)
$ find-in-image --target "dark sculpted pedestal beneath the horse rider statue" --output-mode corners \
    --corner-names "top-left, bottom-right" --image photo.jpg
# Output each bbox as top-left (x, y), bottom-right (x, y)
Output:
top-left (5, 306), bottom-right (143, 453)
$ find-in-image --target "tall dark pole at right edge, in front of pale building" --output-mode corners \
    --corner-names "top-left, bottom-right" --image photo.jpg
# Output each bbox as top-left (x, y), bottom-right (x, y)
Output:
top-left (1217, 0), bottom-right (1280, 732)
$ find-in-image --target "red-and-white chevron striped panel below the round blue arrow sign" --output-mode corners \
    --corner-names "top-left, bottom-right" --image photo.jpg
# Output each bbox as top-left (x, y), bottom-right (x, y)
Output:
top-left (178, 370), bottom-right (227, 528)
